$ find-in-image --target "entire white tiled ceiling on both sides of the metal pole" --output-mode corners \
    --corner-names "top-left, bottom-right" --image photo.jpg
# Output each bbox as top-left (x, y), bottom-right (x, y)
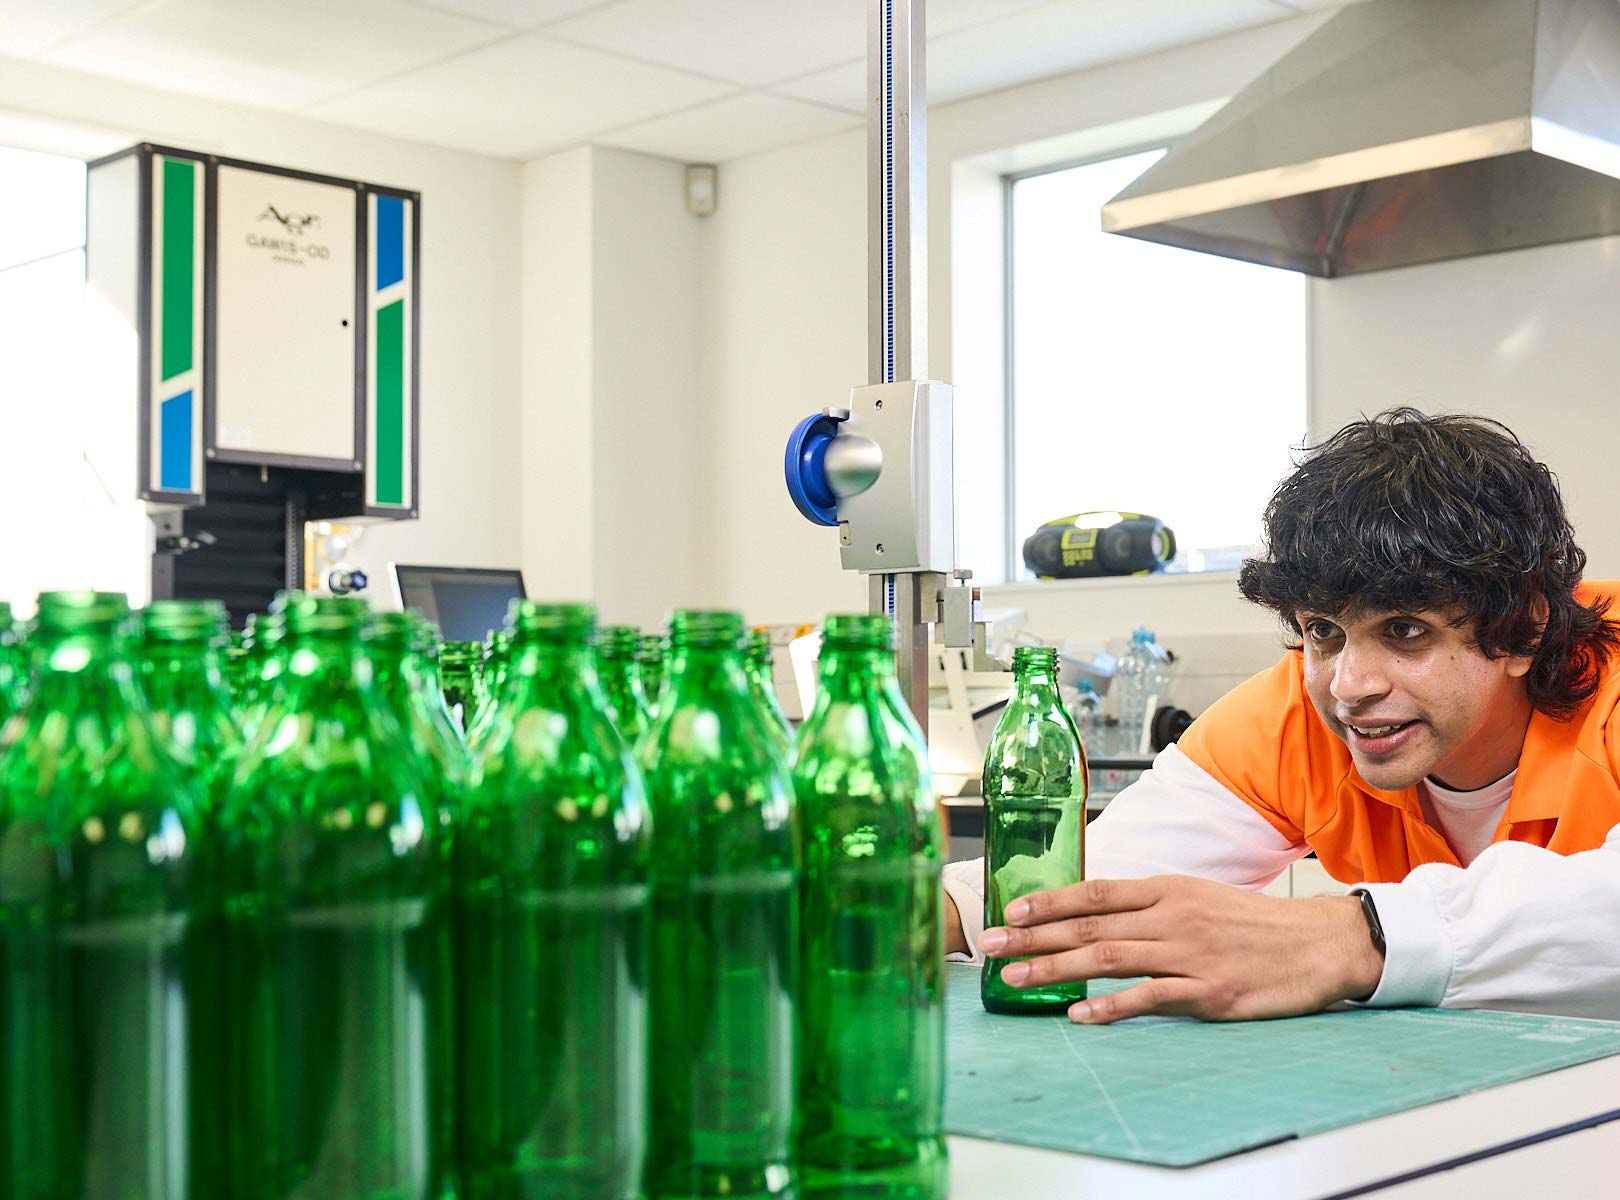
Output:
top-left (0, 0), bottom-right (1360, 162)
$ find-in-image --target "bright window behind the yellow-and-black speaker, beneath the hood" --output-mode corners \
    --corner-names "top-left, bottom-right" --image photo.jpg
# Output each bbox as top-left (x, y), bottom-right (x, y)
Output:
top-left (1008, 149), bottom-right (1306, 580)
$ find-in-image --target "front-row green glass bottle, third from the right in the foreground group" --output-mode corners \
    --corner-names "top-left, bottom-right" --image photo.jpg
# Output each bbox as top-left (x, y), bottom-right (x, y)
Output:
top-left (455, 601), bottom-right (663, 1200)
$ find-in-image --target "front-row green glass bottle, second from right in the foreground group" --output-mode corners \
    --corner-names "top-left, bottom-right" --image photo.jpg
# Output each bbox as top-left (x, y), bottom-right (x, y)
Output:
top-left (637, 611), bottom-right (799, 1200)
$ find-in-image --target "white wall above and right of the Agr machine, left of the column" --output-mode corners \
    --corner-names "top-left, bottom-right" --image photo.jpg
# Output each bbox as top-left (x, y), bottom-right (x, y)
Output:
top-left (0, 58), bottom-right (520, 596)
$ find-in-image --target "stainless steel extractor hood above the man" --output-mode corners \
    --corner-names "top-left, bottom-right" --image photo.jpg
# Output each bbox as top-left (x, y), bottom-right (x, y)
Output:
top-left (1103, 0), bottom-right (1620, 275)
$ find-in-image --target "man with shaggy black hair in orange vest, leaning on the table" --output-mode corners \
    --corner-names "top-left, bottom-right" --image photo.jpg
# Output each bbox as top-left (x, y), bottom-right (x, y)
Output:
top-left (946, 408), bottom-right (1620, 1022)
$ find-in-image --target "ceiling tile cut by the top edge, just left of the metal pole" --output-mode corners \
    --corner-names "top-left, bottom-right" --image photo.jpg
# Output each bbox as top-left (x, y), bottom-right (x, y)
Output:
top-left (546, 0), bottom-right (867, 84)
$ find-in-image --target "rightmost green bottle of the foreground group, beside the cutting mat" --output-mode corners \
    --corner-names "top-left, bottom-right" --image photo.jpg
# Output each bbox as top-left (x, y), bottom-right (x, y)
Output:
top-left (794, 615), bottom-right (949, 1200)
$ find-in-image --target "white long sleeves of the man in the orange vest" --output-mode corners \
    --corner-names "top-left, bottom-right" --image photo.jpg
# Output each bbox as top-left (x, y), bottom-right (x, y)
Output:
top-left (944, 747), bottom-right (1620, 1019)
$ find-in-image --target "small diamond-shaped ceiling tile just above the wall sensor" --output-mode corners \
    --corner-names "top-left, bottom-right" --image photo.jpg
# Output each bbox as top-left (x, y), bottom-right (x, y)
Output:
top-left (596, 92), bottom-right (860, 162)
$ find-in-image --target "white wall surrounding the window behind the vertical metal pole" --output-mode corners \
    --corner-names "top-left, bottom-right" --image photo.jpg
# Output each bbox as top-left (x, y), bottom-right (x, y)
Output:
top-left (703, 16), bottom-right (1320, 663)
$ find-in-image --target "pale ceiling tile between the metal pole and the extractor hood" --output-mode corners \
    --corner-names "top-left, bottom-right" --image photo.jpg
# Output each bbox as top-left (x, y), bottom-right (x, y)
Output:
top-left (928, 0), bottom-right (1286, 104)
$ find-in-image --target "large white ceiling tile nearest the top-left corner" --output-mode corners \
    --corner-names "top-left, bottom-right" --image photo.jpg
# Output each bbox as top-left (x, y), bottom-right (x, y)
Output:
top-left (44, 0), bottom-right (507, 109)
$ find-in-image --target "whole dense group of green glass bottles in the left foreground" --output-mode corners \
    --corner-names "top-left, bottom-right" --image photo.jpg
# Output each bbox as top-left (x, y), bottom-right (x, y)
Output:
top-left (0, 594), bottom-right (944, 1200)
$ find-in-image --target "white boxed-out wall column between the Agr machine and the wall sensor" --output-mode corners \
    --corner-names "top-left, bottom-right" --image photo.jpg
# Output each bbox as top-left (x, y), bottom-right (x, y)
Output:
top-left (522, 147), bottom-right (716, 627)
